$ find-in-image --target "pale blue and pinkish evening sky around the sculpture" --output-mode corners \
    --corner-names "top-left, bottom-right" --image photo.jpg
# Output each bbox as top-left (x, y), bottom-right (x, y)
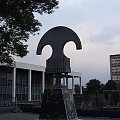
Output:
top-left (15, 0), bottom-right (120, 85)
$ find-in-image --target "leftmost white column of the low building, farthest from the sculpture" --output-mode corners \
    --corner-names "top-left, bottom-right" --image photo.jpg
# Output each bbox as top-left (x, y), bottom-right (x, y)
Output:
top-left (12, 66), bottom-right (16, 102)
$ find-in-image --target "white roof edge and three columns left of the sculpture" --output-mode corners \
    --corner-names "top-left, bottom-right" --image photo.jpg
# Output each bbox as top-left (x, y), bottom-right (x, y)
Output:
top-left (12, 62), bottom-right (45, 102)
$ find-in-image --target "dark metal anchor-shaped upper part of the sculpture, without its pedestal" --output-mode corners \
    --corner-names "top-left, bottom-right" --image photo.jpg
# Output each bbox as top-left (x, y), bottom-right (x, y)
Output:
top-left (37, 26), bottom-right (82, 73)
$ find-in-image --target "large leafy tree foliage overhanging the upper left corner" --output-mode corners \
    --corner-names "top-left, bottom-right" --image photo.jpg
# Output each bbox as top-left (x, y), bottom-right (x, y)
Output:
top-left (0, 0), bottom-right (58, 64)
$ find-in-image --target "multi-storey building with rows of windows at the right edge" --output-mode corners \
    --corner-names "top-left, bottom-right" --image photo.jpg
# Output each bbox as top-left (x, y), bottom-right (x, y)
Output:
top-left (110, 54), bottom-right (120, 81)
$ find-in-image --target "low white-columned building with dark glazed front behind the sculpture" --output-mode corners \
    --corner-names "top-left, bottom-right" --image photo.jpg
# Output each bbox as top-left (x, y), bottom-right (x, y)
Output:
top-left (0, 62), bottom-right (81, 102)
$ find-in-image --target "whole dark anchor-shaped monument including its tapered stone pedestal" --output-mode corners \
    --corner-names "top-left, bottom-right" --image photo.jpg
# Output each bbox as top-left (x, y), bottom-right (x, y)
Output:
top-left (37, 26), bottom-right (82, 120)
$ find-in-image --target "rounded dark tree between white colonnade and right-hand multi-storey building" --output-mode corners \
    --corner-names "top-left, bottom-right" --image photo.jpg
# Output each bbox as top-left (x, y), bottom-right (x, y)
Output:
top-left (85, 79), bottom-right (103, 94)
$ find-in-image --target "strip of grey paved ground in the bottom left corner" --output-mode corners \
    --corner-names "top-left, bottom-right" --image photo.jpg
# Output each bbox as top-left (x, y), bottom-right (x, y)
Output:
top-left (0, 113), bottom-right (39, 120)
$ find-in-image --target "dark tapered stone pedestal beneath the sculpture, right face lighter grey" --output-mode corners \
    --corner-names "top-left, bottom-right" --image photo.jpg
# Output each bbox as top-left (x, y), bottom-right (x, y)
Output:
top-left (39, 88), bottom-right (77, 120)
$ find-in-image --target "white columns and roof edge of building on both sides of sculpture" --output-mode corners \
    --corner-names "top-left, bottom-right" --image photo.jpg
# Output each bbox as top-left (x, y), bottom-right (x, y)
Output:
top-left (12, 63), bottom-right (82, 102)
